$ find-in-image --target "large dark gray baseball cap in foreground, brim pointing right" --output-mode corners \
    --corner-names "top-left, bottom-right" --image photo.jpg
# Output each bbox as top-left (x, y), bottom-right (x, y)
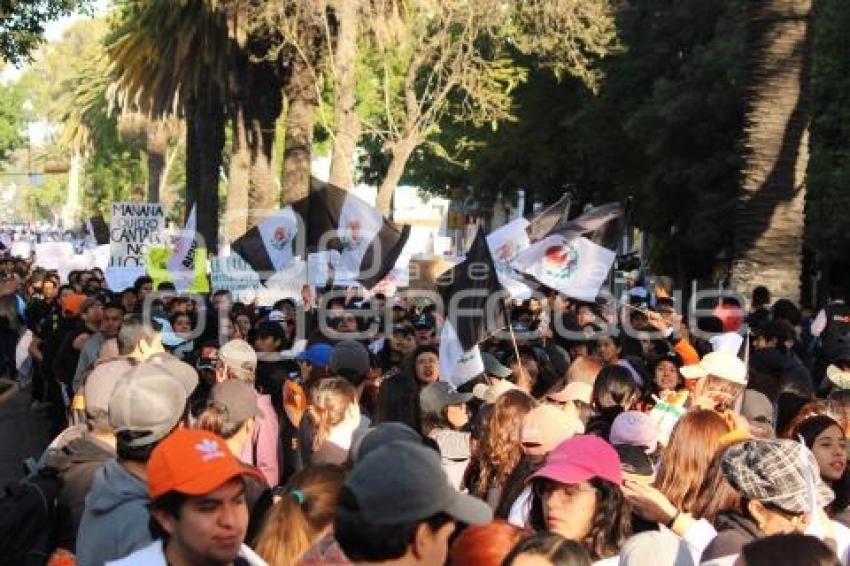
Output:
top-left (337, 441), bottom-right (493, 525)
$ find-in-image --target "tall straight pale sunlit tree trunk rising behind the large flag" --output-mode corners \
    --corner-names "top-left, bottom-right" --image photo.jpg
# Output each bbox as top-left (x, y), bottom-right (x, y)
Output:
top-left (329, 0), bottom-right (360, 189)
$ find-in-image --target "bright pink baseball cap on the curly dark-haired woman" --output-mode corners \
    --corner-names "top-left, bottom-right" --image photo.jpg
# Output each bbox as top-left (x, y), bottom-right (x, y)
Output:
top-left (529, 434), bottom-right (623, 485)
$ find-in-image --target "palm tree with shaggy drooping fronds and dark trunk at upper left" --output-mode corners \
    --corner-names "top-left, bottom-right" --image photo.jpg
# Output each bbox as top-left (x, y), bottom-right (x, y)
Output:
top-left (107, 0), bottom-right (236, 253)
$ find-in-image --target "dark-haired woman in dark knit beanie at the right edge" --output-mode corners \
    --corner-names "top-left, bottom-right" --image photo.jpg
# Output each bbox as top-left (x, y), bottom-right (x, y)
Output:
top-left (791, 415), bottom-right (850, 525)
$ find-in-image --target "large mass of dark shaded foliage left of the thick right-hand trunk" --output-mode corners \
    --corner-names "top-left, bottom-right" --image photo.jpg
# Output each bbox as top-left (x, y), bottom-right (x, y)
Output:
top-left (361, 0), bottom-right (744, 280)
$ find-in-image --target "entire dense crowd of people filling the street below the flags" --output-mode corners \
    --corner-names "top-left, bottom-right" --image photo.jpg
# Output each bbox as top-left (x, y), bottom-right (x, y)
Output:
top-left (0, 254), bottom-right (850, 566)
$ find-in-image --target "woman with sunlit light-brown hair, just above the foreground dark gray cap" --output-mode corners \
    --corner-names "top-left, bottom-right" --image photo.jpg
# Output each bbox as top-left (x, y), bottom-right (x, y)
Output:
top-left (307, 377), bottom-right (360, 466)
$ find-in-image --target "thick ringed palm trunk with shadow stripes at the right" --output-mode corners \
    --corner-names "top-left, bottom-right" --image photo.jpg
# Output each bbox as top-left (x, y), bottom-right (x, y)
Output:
top-left (732, 0), bottom-right (812, 301)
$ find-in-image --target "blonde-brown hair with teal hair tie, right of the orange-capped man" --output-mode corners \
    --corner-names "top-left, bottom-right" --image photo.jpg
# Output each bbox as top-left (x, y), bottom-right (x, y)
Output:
top-left (255, 464), bottom-right (345, 566)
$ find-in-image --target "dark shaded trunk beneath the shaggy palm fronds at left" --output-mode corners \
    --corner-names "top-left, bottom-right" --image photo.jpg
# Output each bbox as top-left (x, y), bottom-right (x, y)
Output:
top-left (185, 83), bottom-right (226, 254)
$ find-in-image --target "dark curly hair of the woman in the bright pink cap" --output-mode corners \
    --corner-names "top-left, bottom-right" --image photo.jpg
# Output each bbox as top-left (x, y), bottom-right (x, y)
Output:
top-left (528, 478), bottom-right (632, 561)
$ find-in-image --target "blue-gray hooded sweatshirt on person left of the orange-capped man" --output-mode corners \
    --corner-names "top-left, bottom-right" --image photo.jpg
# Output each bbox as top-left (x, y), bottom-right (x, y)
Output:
top-left (77, 460), bottom-right (151, 566)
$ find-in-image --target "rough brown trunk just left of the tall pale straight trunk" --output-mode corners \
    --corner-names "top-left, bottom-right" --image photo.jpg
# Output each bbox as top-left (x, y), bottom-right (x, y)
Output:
top-left (280, 58), bottom-right (317, 205)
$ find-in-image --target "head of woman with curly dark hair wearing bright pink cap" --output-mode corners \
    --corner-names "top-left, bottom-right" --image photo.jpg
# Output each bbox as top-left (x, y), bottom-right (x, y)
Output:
top-left (529, 435), bottom-right (632, 561)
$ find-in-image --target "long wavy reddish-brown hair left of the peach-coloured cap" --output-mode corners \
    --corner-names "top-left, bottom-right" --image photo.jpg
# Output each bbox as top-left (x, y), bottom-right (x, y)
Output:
top-left (475, 389), bottom-right (534, 497)
